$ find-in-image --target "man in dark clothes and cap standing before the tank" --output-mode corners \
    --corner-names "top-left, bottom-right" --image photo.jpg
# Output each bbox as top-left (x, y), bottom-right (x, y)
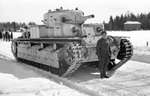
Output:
top-left (96, 31), bottom-right (111, 78)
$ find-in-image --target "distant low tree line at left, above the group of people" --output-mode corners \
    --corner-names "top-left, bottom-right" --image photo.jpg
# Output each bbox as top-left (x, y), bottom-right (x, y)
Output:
top-left (0, 22), bottom-right (36, 32)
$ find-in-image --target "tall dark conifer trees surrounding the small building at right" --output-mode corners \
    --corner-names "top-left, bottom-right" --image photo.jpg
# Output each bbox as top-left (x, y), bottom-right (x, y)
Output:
top-left (104, 11), bottom-right (150, 30)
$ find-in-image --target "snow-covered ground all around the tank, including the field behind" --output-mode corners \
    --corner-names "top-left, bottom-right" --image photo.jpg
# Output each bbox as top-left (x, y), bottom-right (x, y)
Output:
top-left (0, 31), bottom-right (150, 96)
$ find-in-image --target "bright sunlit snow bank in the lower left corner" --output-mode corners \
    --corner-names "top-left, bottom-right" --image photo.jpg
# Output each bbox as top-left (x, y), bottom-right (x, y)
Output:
top-left (0, 73), bottom-right (87, 96)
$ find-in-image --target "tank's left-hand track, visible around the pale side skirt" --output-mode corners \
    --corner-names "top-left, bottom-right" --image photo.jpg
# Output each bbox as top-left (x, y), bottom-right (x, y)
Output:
top-left (11, 41), bottom-right (82, 77)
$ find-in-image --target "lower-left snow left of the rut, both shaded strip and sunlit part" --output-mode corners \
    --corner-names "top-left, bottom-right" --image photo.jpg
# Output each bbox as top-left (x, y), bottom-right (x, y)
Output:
top-left (0, 59), bottom-right (88, 96)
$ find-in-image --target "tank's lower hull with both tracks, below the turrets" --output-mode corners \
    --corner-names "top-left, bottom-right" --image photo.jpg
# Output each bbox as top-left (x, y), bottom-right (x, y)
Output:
top-left (12, 37), bottom-right (133, 77)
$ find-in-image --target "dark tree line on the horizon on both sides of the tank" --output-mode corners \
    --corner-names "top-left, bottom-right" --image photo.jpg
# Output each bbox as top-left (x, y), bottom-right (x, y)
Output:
top-left (0, 11), bottom-right (150, 32)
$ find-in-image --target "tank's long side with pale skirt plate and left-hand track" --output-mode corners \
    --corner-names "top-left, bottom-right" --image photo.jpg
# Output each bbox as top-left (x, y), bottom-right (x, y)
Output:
top-left (12, 38), bottom-right (85, 76)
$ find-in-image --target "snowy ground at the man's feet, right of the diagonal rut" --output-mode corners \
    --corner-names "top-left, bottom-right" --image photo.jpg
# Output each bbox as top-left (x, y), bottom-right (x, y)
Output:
top-left (68, 61), bottom-right (150, 96)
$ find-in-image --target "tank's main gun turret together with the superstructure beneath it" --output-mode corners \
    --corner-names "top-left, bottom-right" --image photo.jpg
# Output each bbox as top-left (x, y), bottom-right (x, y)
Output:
top-left (31, 8), bottom-right (94, 38)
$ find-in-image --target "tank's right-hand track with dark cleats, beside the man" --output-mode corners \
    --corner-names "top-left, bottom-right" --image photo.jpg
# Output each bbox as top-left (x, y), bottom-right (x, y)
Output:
top-left (110, 39), bottom-right (133, 71)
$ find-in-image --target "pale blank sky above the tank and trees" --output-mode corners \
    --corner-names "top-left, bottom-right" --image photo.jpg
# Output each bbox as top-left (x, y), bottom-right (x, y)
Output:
top-left (0, 0), bottom-right (150, 24)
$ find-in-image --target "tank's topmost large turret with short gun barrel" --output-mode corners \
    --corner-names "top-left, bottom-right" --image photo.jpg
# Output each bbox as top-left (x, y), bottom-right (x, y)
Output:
top-left (43, 9), bottom-right (94, 27)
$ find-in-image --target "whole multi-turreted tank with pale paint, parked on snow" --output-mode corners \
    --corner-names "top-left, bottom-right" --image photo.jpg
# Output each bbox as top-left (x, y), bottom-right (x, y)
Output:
top-left (11, 8), bottom-right (133, 77)
